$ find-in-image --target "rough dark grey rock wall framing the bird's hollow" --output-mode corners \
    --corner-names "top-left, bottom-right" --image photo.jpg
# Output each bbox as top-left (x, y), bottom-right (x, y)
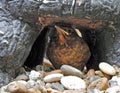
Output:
top-left (0, 0), bottom-right (120, 87)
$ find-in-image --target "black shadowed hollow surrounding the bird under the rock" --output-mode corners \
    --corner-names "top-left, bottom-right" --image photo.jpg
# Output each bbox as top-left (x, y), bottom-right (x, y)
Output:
top-left (24, 22), bottom-right (99, 69)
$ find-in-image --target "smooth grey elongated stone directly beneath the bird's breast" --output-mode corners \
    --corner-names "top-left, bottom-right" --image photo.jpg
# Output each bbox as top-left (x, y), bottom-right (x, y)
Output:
top-left (60, 65), bottom-right (83, 78)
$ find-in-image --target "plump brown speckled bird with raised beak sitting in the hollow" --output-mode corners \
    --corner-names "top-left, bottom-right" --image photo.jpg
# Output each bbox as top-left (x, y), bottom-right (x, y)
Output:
top-left (47, 25), bottom-right (91, 69)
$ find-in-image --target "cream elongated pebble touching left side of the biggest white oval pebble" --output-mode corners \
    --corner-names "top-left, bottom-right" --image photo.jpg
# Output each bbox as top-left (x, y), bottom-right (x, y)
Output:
top-left (44, 74), bottom-right (63, 82)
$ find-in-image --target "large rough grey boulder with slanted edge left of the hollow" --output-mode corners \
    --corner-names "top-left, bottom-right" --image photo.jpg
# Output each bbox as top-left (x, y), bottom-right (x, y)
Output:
top-left (0, 0), bottom-right (38, 84)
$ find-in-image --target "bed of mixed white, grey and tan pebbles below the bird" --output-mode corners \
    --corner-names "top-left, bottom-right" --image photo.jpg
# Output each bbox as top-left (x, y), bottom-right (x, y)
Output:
top-left (0, 60), bottom-right (120, 93)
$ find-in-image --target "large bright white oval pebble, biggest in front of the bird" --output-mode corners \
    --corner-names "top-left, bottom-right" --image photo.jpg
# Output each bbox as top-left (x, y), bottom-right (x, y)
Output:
top-left (61, 76), bottom-right (86, 89)
